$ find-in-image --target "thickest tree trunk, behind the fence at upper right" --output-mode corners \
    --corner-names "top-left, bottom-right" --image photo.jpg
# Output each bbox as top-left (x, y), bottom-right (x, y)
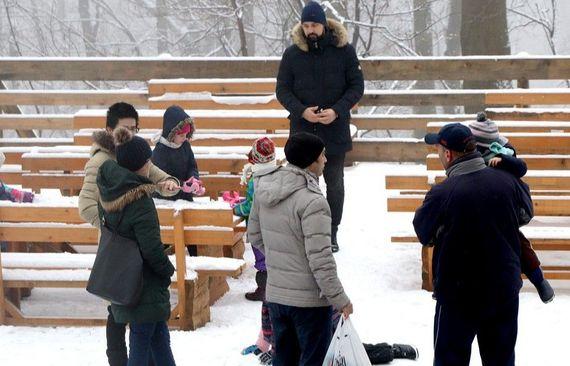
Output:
top-left (461, 0), bottom-right (511, 113)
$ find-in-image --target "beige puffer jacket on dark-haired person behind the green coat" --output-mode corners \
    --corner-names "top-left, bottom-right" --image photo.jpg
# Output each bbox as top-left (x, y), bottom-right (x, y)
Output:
top-left (79, 130), bottom-right (178, 228)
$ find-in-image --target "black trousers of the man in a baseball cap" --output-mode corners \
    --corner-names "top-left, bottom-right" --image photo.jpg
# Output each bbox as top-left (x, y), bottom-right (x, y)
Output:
top-left (433, 297), bottom-right (519, 366)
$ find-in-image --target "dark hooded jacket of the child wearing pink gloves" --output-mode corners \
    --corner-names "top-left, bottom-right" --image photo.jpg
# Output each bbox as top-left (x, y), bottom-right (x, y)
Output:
top-left (151, 106), bottom-right (200, 201)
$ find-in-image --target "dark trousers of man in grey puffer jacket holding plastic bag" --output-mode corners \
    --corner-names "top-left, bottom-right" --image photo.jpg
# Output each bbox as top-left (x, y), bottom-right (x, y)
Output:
top-left (267, 303), bottom-right (332, 366)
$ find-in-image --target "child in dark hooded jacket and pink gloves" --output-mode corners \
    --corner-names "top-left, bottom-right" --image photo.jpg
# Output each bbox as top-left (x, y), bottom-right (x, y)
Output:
top-left (152, 105), bottom-right (205, 201)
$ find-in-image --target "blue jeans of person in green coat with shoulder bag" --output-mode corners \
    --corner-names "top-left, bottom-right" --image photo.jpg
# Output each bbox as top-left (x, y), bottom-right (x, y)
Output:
top-left (127, 322), bottom-right (176, 366)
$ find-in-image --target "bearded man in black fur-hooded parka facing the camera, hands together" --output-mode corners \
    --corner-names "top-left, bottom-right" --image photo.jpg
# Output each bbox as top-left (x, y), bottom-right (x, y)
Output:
top-left (276, 1), bottom-right (364, 252)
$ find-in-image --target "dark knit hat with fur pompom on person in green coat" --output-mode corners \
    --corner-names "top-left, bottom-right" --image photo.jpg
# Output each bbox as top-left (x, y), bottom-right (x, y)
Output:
top-left (113, 127), bottom-right (152, 172)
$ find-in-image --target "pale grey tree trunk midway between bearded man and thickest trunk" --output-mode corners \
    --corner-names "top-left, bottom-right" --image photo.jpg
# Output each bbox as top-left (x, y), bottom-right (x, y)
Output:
top-left (413, 0), bottom-right (435, 117)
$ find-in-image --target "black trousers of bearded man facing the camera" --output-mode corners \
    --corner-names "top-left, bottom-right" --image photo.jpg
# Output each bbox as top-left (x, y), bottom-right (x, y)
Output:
top-left (323, 154), bottom-right (346, 226)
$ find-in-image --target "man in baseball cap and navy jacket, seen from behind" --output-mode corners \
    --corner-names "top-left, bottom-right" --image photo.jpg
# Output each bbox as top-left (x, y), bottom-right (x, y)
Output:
top-left (414, 123), bottom-right (533, 366)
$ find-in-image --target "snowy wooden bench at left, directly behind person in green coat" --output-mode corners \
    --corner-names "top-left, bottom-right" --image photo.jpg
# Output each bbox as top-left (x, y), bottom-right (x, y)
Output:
top-left (0, 199), bottom-right (244, 330)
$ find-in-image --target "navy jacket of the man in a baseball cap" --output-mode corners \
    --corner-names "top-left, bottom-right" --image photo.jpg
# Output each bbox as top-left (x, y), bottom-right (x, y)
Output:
top-left (414, 153), bottom-right (533, 308)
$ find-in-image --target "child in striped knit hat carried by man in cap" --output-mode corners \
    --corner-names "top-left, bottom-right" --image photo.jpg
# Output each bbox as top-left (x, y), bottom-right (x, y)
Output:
top-left (469, 112), bottom-right (555, 304)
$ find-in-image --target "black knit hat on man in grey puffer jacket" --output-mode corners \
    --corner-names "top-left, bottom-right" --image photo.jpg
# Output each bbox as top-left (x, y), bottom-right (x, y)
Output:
top-left (285, 132), bottom-right (325, 169)
